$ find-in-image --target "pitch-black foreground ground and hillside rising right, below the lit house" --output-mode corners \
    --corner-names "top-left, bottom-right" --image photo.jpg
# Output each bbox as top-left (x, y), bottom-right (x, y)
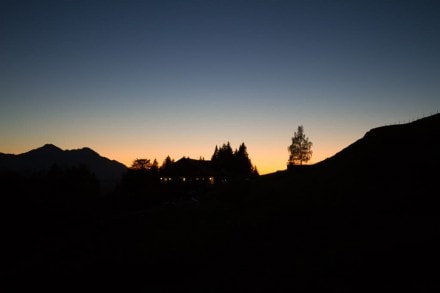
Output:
top-left (1, 115), bottom-right (440, 292)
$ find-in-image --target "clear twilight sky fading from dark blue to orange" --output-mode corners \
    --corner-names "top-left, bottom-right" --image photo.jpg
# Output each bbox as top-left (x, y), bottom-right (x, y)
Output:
top-left (0, 0), bottom-right (440, 174)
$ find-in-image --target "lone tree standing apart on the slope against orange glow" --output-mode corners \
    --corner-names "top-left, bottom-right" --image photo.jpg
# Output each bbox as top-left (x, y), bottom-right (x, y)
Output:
top-left (287, 125), bottom-right (312, 167)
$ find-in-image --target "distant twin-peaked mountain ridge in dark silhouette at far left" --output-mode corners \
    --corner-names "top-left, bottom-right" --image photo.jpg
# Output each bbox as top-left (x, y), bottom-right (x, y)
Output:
top-left (0, 144), bottom-right (127, 185)
